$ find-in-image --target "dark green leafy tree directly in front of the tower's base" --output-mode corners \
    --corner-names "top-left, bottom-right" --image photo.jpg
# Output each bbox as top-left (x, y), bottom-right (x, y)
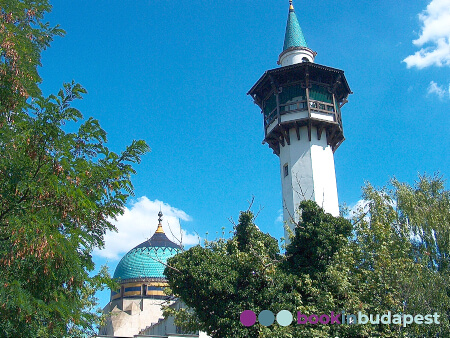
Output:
top-left (281, 201), bottom-right (363, 337)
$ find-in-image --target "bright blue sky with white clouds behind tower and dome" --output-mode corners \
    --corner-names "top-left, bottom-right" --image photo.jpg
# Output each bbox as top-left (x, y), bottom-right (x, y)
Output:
top-left (40, 0), bottom-right (450, 306)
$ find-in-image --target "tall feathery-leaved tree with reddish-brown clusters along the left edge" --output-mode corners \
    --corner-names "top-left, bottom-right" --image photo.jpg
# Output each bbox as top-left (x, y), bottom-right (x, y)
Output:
top-left (0, 0), bottom-right (149, 337)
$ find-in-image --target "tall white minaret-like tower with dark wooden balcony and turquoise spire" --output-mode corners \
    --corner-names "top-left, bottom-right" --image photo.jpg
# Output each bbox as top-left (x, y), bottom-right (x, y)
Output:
top-left (248, 0), bottom-right (351, 240)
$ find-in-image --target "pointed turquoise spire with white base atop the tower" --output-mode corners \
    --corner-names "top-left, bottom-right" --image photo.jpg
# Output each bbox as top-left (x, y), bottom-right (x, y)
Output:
top-left (278, 0), bottom-right (317, 67)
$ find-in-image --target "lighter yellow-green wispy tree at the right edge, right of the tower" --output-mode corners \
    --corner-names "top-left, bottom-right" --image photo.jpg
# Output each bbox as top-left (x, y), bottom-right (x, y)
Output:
top-left (347, 176), bottom-right (450, 337)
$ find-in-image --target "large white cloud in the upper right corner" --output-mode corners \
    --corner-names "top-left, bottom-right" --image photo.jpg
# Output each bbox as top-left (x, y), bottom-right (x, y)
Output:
top-left (403, 0), bottom-right (450, 69)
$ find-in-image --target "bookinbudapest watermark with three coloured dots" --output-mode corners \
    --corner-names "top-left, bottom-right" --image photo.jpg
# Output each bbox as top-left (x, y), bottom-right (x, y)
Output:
top-left (240, 310), bottom-right (440, 327)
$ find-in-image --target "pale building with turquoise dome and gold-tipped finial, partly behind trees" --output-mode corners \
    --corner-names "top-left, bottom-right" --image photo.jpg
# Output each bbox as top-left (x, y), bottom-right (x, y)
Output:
top-left (98, 212), bottom-right (207, 338)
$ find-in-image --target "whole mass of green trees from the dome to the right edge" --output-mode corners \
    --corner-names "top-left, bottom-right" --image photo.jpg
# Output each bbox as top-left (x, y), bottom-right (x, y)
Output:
top-left (165, 176), bottom-right (450, 338)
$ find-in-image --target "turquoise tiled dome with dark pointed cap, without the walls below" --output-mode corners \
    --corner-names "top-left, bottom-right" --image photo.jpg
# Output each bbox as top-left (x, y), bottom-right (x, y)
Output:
top-left (114, 225), bottom-right (181, 281)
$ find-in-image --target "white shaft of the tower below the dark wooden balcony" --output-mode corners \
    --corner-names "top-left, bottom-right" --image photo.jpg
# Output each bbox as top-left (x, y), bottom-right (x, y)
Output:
top-left (280, 126), bottom-right (339, 240)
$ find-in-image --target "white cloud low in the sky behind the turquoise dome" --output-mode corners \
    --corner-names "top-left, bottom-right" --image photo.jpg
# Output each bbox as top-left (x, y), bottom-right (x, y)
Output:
top-left (94, 196), bottom-right (198, 260)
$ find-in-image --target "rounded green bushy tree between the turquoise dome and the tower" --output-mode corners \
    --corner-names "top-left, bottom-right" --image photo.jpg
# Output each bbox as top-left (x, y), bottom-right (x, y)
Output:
top-left (165, 211), bottom-right (279, 337)
